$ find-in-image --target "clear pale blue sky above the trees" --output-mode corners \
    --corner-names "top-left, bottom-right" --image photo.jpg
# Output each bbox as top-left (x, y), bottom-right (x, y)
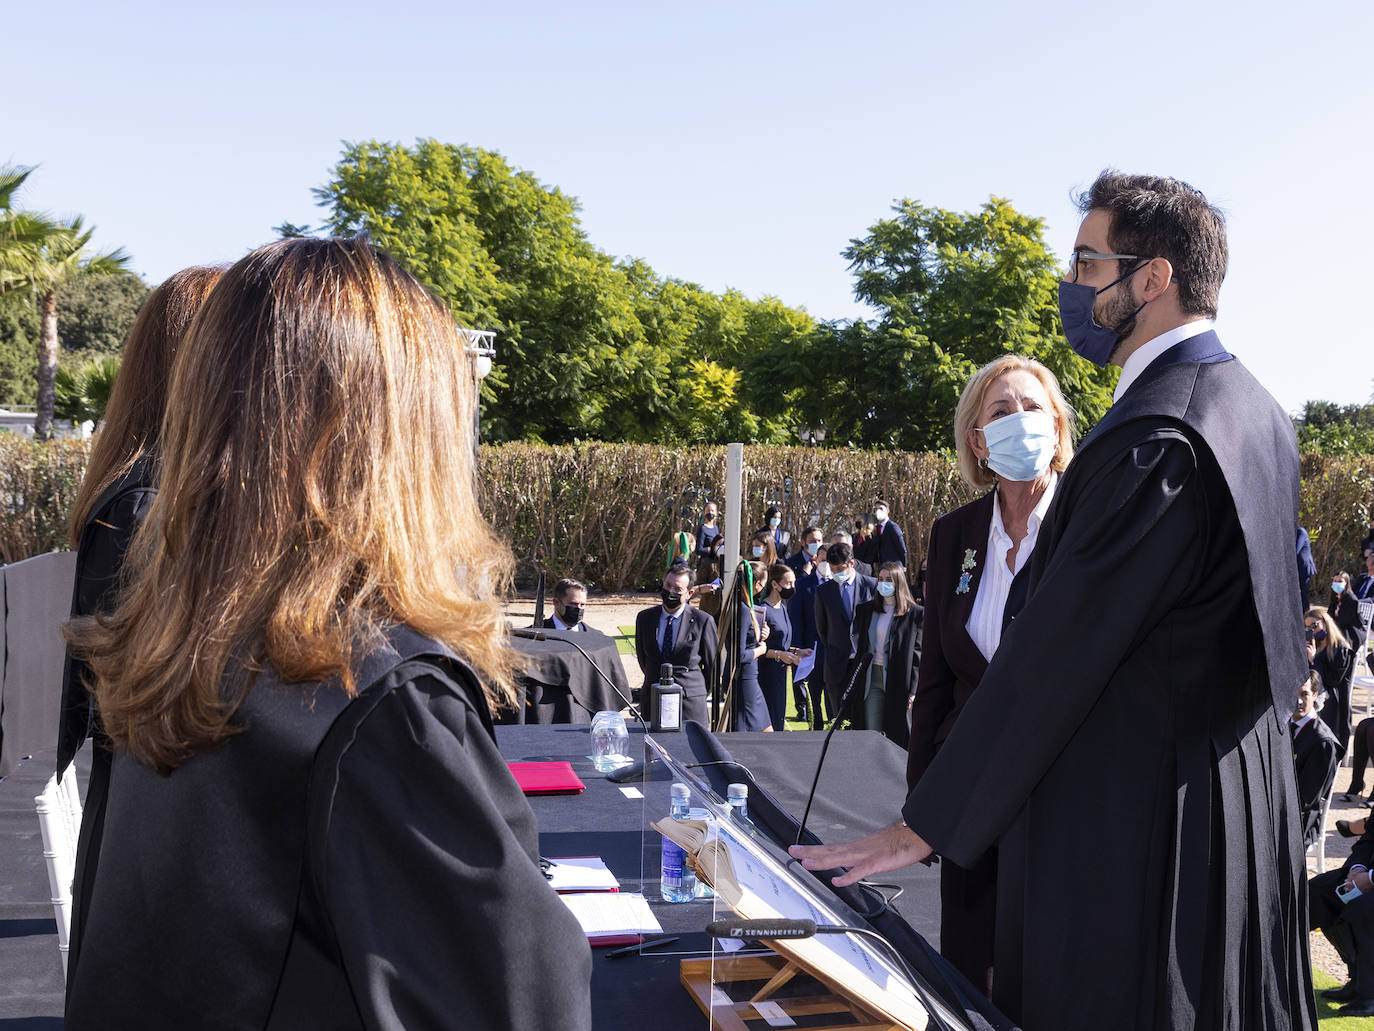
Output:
top-left (0, 0), bottom-right (1374, 411)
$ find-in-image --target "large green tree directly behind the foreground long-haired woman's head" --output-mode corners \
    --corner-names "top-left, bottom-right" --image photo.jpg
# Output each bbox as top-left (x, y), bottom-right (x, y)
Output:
top-left (303, 140), bottom-right (813, 443)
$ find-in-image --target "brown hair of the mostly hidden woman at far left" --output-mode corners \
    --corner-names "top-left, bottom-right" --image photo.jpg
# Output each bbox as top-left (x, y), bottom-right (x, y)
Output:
top-left (67, 265), bottom-right (224, 548)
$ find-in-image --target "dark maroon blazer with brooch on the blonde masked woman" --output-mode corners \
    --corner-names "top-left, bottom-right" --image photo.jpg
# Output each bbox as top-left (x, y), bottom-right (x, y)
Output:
top-left (907, 491), bottom-right (993, 790)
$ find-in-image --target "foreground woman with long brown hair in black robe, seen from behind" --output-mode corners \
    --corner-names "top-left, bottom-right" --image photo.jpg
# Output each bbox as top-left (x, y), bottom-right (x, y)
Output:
top-left (66, 239), bottom-right (591, 1031)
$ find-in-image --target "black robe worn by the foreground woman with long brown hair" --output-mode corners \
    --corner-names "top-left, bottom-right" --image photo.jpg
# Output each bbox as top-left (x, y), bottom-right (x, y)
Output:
top-left (66, 627), bottom-right (591, 1031)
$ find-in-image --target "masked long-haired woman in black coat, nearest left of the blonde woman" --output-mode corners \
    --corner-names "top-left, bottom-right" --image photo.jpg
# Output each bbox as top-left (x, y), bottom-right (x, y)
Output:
top-left (855, 562), bottom-right (925, 748)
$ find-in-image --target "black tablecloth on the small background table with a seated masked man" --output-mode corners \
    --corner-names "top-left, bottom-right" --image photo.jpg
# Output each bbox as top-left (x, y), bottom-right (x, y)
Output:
top-left (510, 630), bottom-right (629, 723)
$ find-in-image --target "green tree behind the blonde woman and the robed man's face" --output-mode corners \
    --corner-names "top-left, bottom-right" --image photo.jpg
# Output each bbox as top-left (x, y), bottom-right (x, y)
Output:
top-left (760, 197), bottom-right (1117, 450)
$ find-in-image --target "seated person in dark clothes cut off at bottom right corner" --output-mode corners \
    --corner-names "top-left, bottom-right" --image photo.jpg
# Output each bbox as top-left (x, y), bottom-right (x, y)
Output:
top-left (1307, 828), bottom-right (1374, 1016)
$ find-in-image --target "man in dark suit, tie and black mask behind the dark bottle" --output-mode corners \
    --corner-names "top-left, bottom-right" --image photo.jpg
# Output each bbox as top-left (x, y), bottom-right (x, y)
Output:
top-left (635, 562), bottom-right (720, 726)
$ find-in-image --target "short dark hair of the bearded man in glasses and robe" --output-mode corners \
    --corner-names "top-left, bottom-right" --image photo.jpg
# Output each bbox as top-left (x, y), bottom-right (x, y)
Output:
top-left (1074, 169), bottom-right (1227, 318)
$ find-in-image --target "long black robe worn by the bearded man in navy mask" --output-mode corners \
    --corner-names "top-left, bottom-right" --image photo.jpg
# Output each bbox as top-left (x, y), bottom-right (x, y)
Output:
top-left (903, 333), bottom-right (1316, 1031)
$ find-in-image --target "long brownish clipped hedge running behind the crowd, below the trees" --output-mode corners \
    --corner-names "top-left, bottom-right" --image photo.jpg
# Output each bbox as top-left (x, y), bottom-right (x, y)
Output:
top-left (0, 434), bottom-right (1374, 598)
